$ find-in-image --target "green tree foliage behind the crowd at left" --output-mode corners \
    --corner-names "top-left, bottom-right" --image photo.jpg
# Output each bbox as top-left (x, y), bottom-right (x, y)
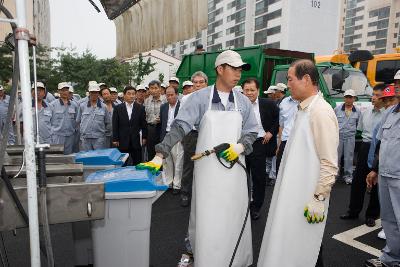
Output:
top-left (0, 45), bottom-right (155, 96)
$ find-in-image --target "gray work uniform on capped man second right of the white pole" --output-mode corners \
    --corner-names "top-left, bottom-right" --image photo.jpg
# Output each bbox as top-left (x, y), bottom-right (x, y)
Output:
top-left (50, 99), bottom-right (78, 155)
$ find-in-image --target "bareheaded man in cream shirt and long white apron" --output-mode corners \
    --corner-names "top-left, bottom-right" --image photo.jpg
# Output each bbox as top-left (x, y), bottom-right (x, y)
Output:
top-left (257, 60), bottom-right (339, 267)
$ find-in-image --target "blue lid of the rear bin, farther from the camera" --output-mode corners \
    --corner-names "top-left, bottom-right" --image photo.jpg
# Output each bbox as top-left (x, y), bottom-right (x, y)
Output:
top-left (75, 148), bottom-right (129, 166)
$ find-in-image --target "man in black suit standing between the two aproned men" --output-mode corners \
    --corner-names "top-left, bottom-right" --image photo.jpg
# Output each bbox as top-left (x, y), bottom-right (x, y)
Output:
top-left (242, 78), bottom-right (279, 220)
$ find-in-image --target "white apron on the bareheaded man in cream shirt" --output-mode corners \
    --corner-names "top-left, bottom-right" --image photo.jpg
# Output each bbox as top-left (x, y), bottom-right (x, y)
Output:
top-left (257, 95), bottom-right (329, 267)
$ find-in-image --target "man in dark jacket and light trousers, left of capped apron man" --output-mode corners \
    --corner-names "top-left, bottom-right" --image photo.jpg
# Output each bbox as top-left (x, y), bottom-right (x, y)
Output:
top-left (160, 86), bottom-right (183, 195)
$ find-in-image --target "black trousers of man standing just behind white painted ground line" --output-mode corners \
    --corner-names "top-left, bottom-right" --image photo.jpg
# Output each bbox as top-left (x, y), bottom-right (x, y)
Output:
top-left (348, 142), bottom-right (380, 219)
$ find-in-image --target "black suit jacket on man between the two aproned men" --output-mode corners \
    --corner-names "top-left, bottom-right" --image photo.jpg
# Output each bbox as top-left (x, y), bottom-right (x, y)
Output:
top-left (258, 97), bottom-right (279, 157)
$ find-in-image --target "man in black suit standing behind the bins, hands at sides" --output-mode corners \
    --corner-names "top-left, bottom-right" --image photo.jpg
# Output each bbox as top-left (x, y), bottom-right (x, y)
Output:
top-left (112, 86), bottom-right (147, 165)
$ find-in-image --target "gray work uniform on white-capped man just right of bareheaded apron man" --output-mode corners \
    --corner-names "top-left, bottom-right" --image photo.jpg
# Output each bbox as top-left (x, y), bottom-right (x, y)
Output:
top-left (335, 104), bottom-right (361, 181)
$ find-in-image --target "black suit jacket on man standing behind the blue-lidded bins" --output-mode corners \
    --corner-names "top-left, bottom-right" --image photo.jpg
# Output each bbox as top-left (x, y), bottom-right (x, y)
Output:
top-left (112, 102), bottom-right (147, 152)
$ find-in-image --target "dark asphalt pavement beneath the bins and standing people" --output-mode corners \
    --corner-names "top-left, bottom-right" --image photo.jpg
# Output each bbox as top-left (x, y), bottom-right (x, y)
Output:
top-left (0, 182), bottom-right (385, 267)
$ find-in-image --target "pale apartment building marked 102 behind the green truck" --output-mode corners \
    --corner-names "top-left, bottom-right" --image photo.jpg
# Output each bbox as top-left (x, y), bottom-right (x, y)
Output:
top-left (162, 0), bottom-right (341, 58)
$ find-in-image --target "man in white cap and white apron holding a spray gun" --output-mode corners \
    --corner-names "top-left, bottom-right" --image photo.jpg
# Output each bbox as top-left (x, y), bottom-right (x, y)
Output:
top-left (136, 50), bottom-right (258, 267)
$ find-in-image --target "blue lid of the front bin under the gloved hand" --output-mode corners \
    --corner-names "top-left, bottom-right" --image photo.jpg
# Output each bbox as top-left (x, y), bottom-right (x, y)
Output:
top-left (86, 166), bottom-right (168, 193)
